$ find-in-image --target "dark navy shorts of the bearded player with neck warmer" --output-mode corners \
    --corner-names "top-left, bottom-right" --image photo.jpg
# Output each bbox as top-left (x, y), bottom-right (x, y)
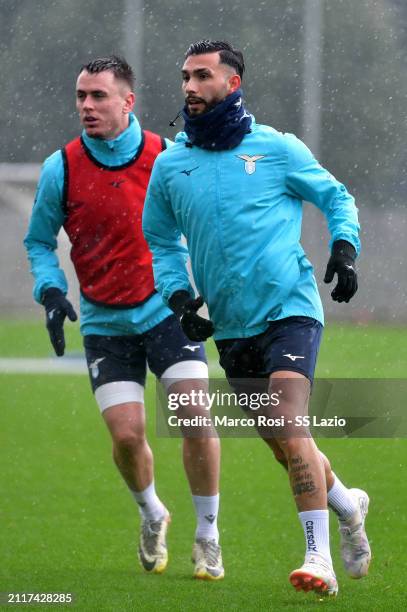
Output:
top-left (216, 317), bottom-right (323, 383)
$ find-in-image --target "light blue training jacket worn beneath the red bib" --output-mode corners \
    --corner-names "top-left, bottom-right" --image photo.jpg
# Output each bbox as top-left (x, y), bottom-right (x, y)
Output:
top-left (24, 114), bottom-right (172, 336)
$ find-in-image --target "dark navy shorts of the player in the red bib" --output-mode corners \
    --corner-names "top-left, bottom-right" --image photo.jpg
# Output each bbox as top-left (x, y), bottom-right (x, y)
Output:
top-left (83, 315), bottom-right (206, 391)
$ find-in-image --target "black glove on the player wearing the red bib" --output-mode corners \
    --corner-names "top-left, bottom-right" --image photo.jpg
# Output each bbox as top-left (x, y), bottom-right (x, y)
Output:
top-left (42, 287), bottom-right (78, 357)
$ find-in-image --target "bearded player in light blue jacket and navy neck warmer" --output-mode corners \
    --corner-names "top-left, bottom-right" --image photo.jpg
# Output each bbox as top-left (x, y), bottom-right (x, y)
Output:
top-left (143, 40), bottom-right (371, 595)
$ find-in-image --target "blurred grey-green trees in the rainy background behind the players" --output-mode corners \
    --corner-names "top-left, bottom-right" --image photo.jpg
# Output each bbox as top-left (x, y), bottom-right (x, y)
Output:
top-left (0, 0), bottom-right (407, 207)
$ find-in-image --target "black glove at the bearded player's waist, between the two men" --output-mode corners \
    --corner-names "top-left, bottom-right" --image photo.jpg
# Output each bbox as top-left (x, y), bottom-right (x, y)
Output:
top-left (168, 290), bottom-right (215, 342)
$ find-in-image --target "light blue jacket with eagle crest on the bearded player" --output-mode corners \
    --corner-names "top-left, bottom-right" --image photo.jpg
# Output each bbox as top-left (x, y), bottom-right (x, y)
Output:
top-left (143, 118), bottom-right (360, 339)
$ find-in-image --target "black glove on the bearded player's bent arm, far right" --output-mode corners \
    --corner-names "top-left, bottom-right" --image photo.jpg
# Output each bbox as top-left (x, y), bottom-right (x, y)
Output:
top-left (324, 240), bottom-right (358, 302)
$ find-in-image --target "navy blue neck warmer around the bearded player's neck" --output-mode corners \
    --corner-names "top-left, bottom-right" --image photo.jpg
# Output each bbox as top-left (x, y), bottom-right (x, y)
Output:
top-left (182, 89), bottom-right (252, 151)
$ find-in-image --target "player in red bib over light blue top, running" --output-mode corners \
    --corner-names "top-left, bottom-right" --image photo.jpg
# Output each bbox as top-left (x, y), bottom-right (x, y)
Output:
top-left (24, 56), bottom-right (224, 580)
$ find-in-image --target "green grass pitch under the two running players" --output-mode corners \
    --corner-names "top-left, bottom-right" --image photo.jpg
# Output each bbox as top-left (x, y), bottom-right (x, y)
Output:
top-left (0, 322), bottom-right (407, 612)
